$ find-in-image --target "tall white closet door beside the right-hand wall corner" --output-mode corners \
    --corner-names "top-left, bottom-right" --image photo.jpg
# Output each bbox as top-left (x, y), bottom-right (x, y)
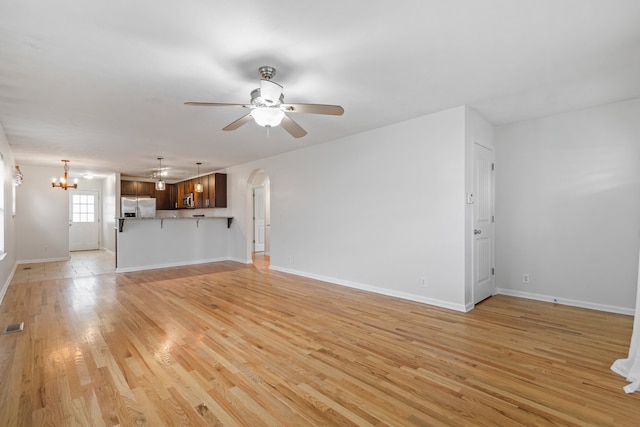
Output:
top-left (473, 144), bottom-right (495, 303)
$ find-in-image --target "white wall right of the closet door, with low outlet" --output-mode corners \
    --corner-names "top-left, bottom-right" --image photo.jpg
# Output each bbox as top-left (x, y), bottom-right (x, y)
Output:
top-left (496, 99), bottom-right (640, 314)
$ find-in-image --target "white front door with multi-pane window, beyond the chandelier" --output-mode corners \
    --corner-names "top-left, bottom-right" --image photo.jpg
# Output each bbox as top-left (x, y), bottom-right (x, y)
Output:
top-left (69, 190), bottom-right (100, 251)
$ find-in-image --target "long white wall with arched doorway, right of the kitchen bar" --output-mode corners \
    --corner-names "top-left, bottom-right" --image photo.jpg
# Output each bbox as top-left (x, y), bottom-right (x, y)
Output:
top-left (228, 107), bottom-right (467, 310)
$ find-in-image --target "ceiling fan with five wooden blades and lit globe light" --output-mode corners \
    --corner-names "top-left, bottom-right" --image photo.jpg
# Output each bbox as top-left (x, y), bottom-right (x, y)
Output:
top-left (185, 66), bottom-right (344, 138)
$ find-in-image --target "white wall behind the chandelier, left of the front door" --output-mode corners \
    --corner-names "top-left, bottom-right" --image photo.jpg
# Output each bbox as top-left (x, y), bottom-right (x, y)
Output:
top-left (16, 166), bottom-right (69, 262)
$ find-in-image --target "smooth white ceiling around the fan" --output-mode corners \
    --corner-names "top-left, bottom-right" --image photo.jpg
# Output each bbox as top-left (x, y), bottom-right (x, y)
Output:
top-left (0, 0), bottom-right (640, 179)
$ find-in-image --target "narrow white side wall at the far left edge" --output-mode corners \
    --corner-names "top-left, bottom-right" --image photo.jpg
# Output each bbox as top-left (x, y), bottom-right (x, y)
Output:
top-left (0, 125), bottom-right (21, 302)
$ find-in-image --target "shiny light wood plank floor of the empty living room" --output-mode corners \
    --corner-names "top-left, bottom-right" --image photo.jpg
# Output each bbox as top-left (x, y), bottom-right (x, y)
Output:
top-left (0, 262), bottom-right (640, 427)
